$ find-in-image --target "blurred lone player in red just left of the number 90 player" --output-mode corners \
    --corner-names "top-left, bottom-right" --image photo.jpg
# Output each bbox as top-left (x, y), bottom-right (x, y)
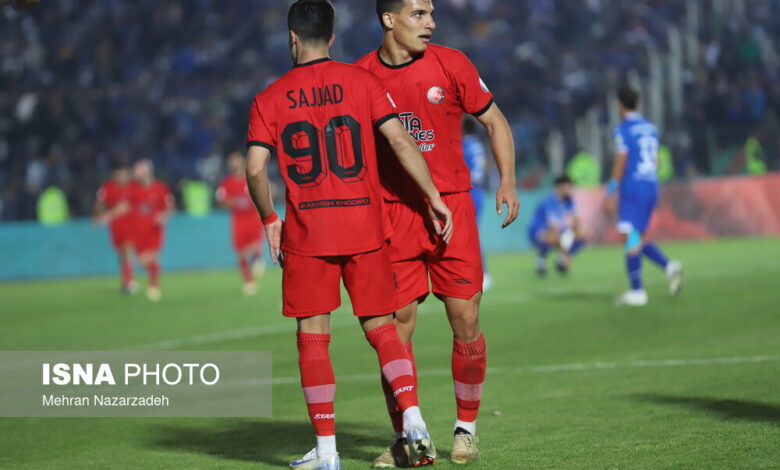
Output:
top-left (217, 152), bottom-right (265, 295)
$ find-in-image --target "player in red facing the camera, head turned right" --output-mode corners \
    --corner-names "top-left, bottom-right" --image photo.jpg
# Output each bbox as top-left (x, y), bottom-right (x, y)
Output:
top-left (356, 0), bottom-right (520, 467)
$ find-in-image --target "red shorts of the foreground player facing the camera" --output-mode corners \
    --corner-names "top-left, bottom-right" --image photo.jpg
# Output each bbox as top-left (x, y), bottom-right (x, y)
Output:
top-left (386, 192), bottom-right (483, 308)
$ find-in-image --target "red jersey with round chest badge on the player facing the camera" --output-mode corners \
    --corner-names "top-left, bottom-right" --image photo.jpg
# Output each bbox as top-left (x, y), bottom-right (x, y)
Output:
top-left (355, 44), bottom-right (493, 201)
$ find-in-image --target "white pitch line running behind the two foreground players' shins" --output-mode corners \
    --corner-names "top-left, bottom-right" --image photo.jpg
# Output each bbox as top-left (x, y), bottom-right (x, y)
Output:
top-left (264, 355), bottom-right (780, 385)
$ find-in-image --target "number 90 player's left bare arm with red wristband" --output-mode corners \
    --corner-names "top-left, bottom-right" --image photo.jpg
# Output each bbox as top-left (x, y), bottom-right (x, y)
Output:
top-left (246, 146), bottom-right (282, 264)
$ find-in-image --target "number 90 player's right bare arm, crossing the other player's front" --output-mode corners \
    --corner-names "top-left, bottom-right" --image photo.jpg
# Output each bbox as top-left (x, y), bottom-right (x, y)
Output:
top-left (379, 119), bottom-right (453, 243)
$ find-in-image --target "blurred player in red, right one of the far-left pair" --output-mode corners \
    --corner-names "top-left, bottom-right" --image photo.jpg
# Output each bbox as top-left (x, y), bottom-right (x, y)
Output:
top-left (130, 160), bottom-right (174, 302)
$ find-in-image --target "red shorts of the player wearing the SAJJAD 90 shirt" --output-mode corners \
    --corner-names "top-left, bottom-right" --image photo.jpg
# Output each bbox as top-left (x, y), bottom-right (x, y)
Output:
top-left (282, 247), bottom-right (398, 317)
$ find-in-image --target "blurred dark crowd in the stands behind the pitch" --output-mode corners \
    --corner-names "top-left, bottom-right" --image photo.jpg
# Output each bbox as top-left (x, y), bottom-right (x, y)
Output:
top-left (0, 0), bottom-right (780, 220)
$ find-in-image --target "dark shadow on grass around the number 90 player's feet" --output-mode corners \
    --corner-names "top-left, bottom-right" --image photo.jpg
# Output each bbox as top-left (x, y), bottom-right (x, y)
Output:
top-left (149, 421), bottom-right (387, 467)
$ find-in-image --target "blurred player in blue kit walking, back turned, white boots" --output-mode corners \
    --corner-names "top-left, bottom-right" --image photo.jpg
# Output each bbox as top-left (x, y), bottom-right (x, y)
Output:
top-left (606, 88), bottom-right (682, 306)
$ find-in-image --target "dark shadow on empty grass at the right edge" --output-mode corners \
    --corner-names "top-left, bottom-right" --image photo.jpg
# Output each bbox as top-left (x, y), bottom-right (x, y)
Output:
top-left (635, 395), bottom-right (780, 426)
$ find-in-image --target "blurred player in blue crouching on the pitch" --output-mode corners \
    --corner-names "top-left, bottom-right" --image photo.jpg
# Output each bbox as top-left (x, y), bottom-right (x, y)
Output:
top-left (528, 175), bottom-right (585, 276)
